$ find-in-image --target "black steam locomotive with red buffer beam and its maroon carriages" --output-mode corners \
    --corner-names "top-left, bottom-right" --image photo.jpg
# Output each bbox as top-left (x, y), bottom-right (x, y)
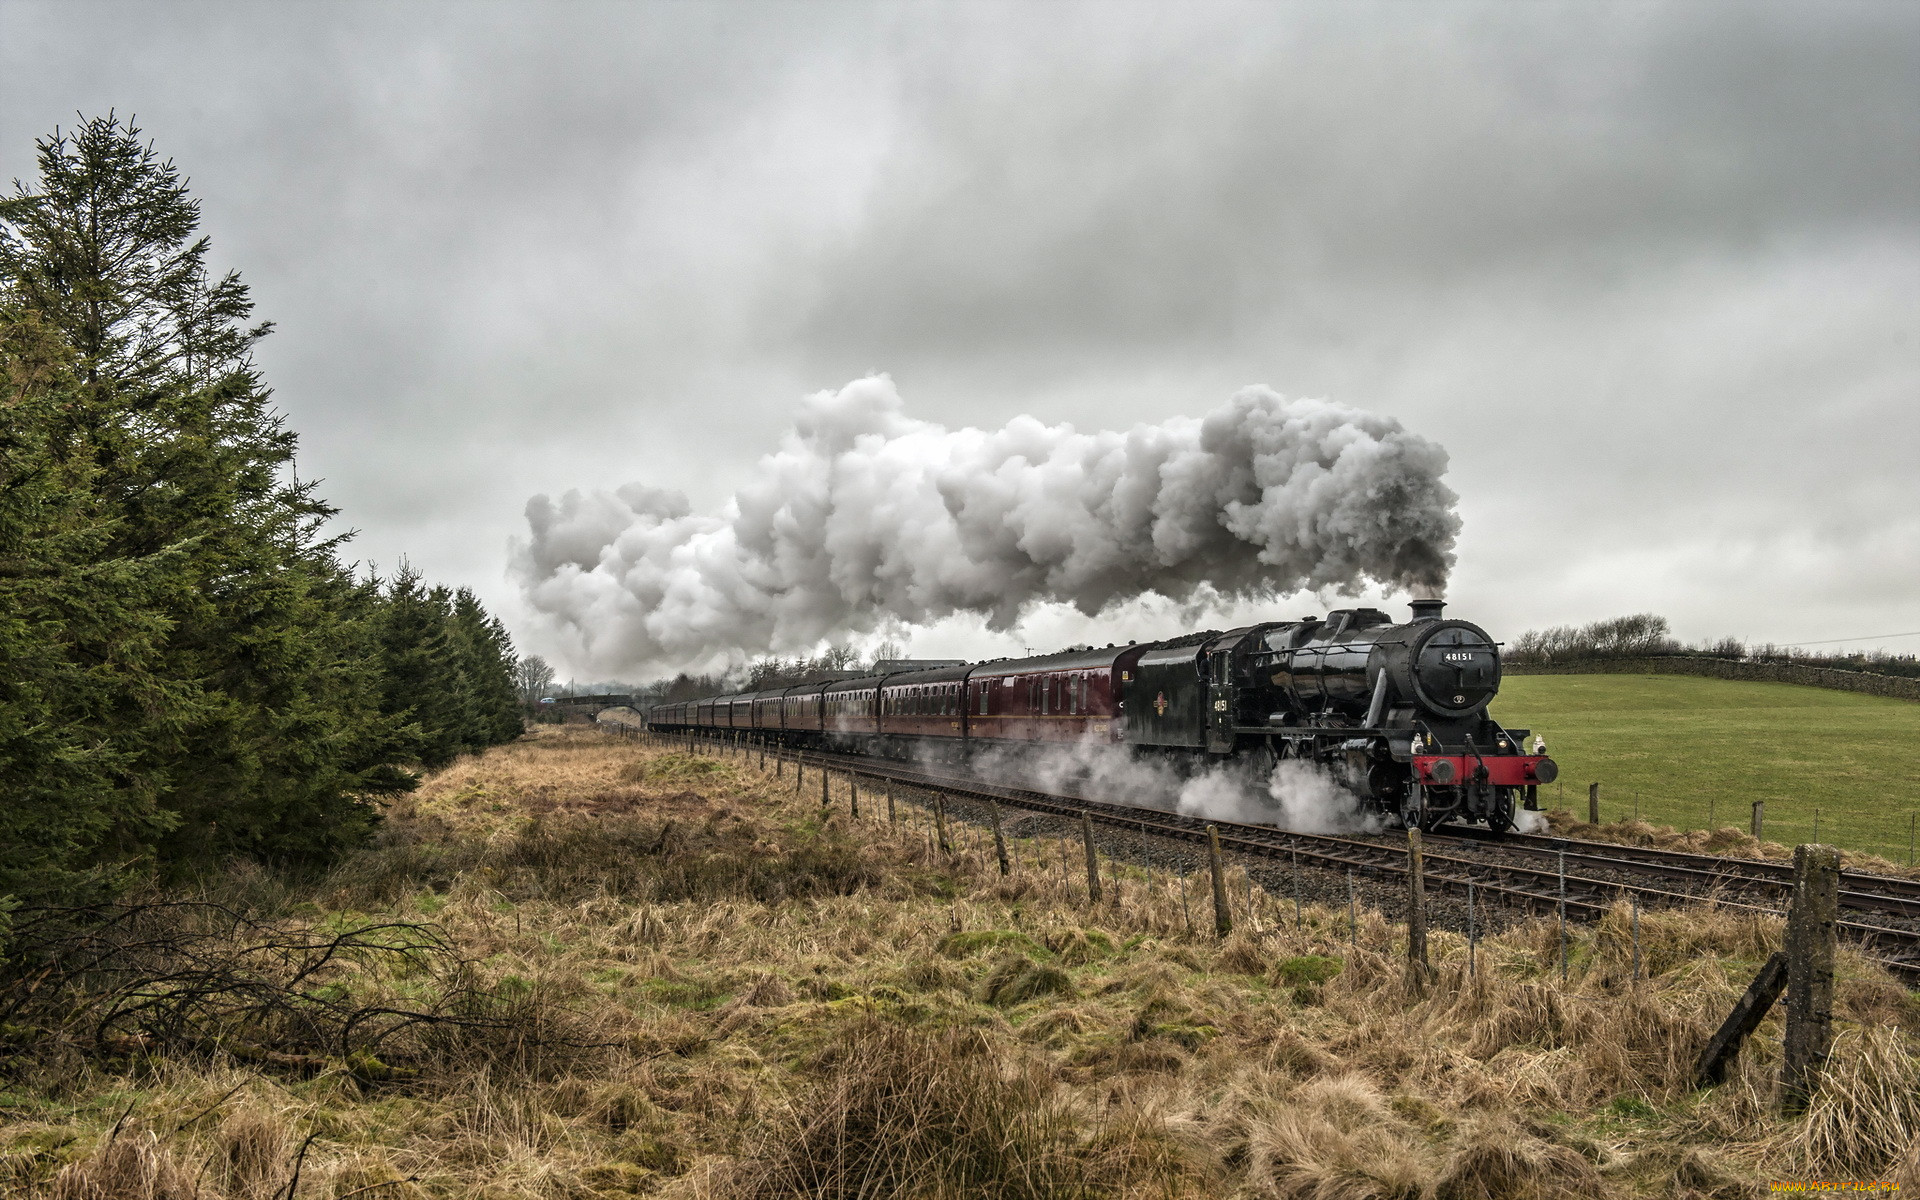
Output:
top-left (647, 599), bottom-right (1557, 831)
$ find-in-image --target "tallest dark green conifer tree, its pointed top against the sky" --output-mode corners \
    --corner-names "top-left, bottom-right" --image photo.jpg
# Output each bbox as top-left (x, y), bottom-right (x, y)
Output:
top-left (0, 115), bottom-right (403, 883)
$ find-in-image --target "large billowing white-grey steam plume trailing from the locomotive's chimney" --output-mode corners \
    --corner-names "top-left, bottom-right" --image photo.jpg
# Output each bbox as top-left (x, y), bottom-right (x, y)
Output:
top-left (516, 376), bottom-right (1459, 672)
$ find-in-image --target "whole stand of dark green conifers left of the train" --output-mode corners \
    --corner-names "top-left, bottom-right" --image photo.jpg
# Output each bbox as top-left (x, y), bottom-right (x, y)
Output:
top-left (0, 115), bottom-right (522, 906)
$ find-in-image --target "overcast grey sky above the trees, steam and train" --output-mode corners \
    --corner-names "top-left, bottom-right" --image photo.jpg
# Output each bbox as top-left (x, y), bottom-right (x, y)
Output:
top-left (0, 0), bottom-right (1920, 674)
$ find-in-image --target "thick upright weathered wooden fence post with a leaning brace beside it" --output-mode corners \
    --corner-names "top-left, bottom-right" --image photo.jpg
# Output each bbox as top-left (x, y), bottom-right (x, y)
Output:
top-left (1780, 845), bottom-right (1839, 1114)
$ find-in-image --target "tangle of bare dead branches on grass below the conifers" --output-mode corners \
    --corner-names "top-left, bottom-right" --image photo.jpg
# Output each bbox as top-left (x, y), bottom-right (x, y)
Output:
top-left (0, 900), bottom-right (607, 1085)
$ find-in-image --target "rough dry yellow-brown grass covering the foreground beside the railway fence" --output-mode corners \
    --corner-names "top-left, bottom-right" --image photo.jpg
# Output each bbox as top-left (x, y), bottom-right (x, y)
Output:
top-left (0, 730), bottom-right (1920, 1200)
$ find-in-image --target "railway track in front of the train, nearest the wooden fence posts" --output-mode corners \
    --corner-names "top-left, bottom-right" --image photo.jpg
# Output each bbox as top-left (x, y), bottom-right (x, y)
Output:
top-left (648, 725), bottom-right (1920, 985)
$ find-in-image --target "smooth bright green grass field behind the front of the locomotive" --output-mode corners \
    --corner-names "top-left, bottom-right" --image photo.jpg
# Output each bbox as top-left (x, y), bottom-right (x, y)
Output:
top-left (1494, 676), bottom-right (1920, 864)
